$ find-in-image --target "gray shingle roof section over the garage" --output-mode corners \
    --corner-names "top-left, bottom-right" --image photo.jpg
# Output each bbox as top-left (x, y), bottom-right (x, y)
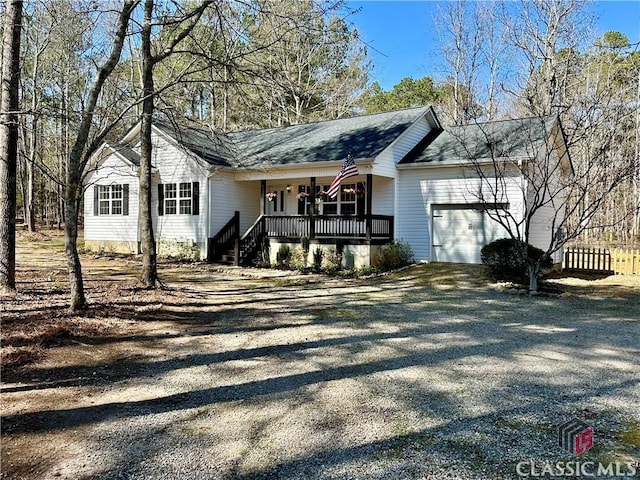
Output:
top-left (400, 117), bottom-right (555, 165)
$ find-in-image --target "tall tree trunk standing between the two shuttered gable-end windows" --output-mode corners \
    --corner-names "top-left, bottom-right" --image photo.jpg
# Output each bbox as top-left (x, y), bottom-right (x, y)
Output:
top-left (138, 0), bottom-right (158, 288)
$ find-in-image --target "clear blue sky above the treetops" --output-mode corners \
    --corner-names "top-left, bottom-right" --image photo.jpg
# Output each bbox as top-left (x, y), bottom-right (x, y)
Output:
top-left (348, 0), bottom-right (640, 90)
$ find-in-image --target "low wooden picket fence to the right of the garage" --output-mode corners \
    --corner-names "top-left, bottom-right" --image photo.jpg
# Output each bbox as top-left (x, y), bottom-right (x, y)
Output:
top-left (562, 247), bottom-right (640, 275)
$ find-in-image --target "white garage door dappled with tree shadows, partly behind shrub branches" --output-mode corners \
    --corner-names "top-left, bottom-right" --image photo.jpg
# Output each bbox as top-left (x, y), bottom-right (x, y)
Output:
top-left (432, 206), bottom-right (508, 263)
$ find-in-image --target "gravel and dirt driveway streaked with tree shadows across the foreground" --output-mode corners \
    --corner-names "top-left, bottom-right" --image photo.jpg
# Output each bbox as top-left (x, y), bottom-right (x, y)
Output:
top-left (0, 234), bottom-right (640, 479)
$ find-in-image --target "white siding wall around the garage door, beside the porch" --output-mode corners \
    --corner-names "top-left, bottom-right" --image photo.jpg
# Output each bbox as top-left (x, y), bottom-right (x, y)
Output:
top-left (395, 167), bottom-right (523, 261)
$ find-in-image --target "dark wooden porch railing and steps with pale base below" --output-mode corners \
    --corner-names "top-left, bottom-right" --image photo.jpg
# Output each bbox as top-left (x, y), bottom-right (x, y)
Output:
top-left (207, 212), bottom-right (394, 268)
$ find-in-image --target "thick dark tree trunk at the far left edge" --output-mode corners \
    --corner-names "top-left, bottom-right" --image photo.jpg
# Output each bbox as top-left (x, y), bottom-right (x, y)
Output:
top-left (0, 0), bottom-right (22, 292)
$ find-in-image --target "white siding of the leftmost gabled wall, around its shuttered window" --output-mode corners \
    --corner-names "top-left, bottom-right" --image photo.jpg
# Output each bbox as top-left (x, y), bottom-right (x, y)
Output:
top-left (84, 154), bottom-right (138, 242)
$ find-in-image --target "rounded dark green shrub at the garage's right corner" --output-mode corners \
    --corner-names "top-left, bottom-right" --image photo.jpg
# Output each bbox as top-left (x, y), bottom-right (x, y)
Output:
top-left (480, 238), bottom-right (553, 283)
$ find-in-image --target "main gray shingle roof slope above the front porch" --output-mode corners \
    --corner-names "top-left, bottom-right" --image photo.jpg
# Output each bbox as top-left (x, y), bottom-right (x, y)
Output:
top-left (229, 107), bottom-right (428, 168)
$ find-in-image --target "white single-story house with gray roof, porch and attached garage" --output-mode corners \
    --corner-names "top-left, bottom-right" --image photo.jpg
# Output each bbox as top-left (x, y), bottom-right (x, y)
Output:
top-left (84, 107), bottom-right (570, 266)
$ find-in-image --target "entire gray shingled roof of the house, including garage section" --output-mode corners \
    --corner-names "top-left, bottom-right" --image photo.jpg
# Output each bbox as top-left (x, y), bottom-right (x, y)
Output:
top-left (145, 107), bottom-right (555, 168)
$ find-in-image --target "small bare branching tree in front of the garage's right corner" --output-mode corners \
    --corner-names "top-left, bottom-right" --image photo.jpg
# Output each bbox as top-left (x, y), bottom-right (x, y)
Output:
top-left (454, 111), bottom-right (635, 293)
